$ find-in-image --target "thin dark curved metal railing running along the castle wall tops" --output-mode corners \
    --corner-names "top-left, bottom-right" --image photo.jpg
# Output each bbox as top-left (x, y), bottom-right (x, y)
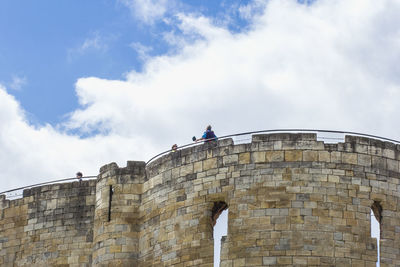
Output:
top-left (0, 129), bottom-right (400, 200)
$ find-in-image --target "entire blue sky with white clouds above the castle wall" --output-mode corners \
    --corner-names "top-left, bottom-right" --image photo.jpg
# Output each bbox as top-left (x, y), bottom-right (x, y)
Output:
top-left (0, 0), bottom-right (400, 191)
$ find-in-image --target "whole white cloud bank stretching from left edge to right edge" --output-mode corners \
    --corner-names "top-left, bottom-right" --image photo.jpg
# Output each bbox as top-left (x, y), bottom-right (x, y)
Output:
top-left (0, 0), bottom-right (400, 194)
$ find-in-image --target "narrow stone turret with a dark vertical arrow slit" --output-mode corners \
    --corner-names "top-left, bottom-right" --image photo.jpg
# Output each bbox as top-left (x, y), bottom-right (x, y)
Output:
top-left (93, 161), bottom-right (145, 266)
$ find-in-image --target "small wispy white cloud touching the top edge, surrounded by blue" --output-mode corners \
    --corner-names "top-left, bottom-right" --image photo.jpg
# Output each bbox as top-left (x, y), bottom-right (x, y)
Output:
top-left (119, 0), bottom-right (173, 24)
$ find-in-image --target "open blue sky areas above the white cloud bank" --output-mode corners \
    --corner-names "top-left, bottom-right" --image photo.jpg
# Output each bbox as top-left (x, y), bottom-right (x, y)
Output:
top-left (0, 0), bottom-right (253, 124)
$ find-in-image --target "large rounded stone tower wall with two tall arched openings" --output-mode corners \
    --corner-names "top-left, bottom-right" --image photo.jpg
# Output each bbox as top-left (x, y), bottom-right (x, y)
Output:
top-left (139, 133), bottom-right (400, 266)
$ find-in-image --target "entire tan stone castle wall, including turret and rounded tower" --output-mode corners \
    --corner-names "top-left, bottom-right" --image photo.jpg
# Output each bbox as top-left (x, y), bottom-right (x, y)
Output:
top-left (0, 134), bottom-right (400, 267)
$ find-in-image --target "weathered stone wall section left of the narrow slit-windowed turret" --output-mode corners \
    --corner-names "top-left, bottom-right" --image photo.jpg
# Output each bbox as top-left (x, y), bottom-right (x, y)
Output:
top-left (0, 181), bottom-right (96, 266)
